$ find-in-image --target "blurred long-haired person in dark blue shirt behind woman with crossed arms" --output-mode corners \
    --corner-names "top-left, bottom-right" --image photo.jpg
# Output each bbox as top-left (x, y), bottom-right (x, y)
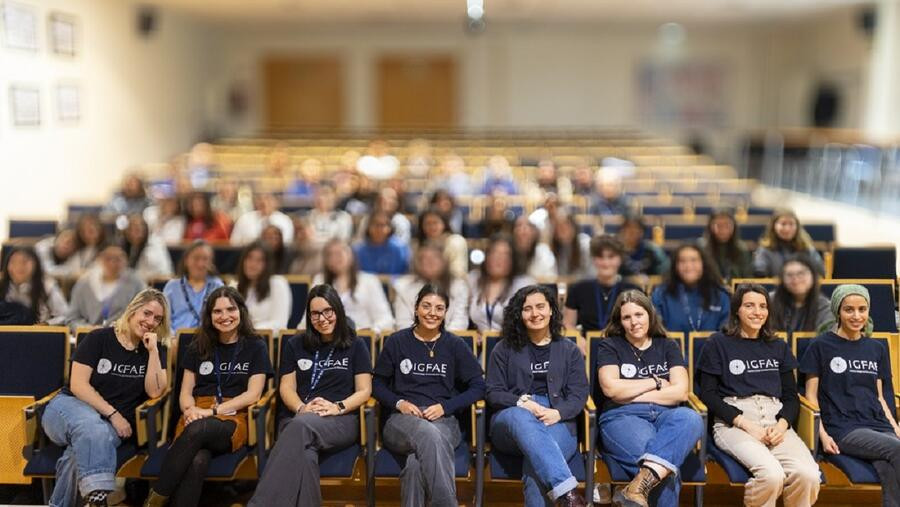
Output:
top-left (653, 244), bottom-right (729, 336)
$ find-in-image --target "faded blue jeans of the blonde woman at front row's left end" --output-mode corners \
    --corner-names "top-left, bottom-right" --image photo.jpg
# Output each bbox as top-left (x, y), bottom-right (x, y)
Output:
top-left (41, 394), bottom-right (120, 507)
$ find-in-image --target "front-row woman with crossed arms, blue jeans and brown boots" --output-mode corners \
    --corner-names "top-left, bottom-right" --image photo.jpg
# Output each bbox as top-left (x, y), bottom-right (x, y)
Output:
top-left (592, 290), bottom-right (705, 507)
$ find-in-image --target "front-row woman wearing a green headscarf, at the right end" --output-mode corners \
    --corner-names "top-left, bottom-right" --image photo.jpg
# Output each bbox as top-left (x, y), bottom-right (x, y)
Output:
top-left (800, 285), bottom-right (900, 506)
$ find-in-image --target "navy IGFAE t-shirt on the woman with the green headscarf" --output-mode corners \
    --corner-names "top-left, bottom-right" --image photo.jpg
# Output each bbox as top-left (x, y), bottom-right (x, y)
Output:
top-left (800, 333), bottom-right (894, 441)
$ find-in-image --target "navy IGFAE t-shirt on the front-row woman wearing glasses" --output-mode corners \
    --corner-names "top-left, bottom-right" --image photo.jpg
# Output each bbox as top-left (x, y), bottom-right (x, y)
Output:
top-left (278, 334), bottom-right (372, 403)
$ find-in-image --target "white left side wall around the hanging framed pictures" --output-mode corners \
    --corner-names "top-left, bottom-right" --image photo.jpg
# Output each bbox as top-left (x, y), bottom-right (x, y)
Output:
top-left (0, 0), bottom-right (211, 238)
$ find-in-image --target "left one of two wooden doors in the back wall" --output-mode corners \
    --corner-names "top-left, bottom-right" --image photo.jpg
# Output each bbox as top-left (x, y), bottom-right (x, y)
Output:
top-left (263, 56), bottom-right (344, 128)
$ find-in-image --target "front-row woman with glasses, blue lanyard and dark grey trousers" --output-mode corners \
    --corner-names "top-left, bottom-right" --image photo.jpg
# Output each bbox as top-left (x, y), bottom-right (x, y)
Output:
top-left (248, 285), bottom-right (372, 507)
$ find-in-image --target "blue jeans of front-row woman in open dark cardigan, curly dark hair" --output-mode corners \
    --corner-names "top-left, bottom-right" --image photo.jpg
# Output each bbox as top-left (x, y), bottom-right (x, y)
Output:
top-left (491, 396), bottom-right (578, 507)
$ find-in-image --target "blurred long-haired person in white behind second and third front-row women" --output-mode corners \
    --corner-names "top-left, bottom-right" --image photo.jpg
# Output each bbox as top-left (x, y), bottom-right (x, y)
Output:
top-left (232, 241), bottom-right (292, 330)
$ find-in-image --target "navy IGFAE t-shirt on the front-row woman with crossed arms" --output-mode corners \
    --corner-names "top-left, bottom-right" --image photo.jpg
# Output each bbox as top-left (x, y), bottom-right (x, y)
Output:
top-left (595, 336), bottom-right (686, 412)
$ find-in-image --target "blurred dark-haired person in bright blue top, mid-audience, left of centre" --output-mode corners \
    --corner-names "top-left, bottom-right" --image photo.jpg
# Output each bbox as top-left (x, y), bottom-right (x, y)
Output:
top-left (354, 211), bottom-right (410, 275)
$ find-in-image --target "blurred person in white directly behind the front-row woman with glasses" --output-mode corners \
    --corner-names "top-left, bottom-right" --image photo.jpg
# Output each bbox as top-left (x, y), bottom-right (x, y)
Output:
top-left (297, 239), bottom-right (395, 333)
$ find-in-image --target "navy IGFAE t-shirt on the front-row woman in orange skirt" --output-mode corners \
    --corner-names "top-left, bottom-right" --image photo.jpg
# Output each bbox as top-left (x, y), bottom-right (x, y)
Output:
top-left (184, 338), bottom-right (272, 398)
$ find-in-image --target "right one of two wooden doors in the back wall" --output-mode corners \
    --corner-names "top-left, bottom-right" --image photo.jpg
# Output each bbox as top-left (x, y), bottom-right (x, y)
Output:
top-left (378, 56), bottom-right (457, 128)
